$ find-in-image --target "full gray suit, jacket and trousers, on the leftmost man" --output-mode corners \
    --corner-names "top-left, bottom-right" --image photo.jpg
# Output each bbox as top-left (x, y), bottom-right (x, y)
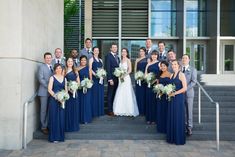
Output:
top-left (38, 64), bottom-right (53, 129)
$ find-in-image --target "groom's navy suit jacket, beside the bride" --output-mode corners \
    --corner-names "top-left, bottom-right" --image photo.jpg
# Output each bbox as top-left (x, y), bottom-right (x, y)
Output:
top-left (105, 52), bottom-right (120, 80)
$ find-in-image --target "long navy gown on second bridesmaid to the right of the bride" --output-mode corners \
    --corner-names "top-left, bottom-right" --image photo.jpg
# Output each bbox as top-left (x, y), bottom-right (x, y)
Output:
top-left (145, 62), bottom-right (159, 123)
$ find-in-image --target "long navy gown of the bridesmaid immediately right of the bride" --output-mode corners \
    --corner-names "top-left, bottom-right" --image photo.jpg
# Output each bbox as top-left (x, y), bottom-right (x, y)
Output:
top-left (135, 58), bottom-right (147, 115)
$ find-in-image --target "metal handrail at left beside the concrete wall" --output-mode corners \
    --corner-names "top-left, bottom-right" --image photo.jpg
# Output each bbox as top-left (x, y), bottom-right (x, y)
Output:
top-left (22, 92), bottom-right (38, 149)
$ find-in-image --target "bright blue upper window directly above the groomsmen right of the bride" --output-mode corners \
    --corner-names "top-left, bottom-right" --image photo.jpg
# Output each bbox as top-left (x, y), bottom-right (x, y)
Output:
top-left (151, 0), bottom-right (176, 37)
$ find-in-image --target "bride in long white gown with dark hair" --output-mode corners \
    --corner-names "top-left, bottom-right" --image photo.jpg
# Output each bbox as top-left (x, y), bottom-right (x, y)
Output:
top-left (113, 48), bottom-right (139, 116)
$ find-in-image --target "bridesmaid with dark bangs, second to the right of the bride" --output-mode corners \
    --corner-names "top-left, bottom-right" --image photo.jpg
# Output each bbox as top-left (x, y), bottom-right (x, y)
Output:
top-left (145, 50), bottom-right (160, 124)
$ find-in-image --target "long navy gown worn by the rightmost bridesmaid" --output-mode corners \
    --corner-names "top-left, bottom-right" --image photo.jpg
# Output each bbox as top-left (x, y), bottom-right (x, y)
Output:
top-left (166, 72), bottom-right (185, 145)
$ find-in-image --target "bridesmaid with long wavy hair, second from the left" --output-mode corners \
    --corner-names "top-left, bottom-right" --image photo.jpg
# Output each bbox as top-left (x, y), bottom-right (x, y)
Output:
top-left (65, 57), bottom-right (80, 132)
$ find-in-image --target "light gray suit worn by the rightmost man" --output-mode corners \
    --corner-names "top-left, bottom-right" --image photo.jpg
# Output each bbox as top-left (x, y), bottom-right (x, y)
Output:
top-left (184, 66), bottom-right (197, 128)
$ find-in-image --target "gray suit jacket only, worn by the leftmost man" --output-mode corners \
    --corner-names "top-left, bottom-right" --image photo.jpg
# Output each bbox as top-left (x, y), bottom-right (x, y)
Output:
top-left (38, 64), bottom-right (53, 96)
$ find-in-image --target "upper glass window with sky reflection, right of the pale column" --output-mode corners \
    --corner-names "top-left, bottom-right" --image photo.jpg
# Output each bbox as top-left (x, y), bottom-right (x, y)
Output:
top-left (185, 0), bottom-right (206, 37)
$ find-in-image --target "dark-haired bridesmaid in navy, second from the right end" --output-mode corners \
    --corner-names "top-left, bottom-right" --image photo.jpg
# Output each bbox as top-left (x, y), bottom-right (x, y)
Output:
top-left (157, 61), bottom-right (171, 133)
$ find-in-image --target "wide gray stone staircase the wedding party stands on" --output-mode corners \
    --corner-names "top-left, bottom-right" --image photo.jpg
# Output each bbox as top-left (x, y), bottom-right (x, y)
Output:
top-left (34, 86), bottom-right (235, 140)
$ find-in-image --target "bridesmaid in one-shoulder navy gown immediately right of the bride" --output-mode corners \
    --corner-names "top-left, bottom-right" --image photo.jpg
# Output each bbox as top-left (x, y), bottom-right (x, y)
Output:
top-left (135, 47), bottom-right (148, 115)
